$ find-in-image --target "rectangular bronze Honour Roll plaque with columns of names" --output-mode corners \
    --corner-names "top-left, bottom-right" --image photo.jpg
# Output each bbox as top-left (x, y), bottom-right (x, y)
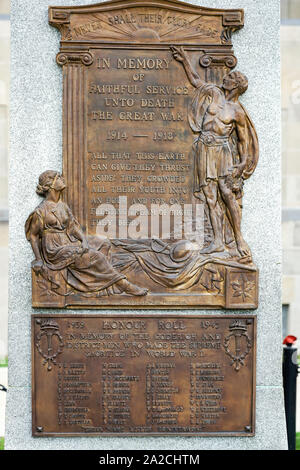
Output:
top-left (32, 314), bottom-right (256, 436)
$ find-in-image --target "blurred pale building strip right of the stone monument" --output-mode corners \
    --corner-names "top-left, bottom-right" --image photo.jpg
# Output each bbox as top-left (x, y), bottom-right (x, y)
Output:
top-left (281, 0), bottom-right (300, 345)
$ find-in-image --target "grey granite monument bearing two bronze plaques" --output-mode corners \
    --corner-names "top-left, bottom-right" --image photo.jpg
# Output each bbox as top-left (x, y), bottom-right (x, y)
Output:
top-left (6, 0), bottom-right (286, 450)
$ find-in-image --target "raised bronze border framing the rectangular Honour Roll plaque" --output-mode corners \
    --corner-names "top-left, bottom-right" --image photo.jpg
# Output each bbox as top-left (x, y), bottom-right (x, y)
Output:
top-left (31, 313), bottom-right (257, 438)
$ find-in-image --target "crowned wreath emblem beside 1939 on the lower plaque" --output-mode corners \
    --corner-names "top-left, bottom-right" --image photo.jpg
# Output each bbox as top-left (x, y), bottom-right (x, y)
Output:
top-left (36, 319), bottom-right (64, 371)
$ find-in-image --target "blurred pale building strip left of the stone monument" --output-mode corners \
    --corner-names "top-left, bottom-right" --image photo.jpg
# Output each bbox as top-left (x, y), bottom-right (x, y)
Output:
top-left (0, 0), bottom-right (10, 359)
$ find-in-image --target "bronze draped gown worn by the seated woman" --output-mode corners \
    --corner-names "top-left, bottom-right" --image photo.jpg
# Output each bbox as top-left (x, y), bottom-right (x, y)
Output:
top-left (25, 201), bottom-right (125, 293)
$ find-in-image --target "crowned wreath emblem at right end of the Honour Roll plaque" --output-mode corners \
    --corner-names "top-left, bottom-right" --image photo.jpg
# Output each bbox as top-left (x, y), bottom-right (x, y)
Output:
top-left (224, 320), bottom-right (252, 372)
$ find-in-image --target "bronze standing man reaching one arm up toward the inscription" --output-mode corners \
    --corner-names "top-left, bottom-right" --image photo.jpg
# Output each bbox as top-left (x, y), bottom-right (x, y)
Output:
top-left (171, 46), bottom-right (258, 258)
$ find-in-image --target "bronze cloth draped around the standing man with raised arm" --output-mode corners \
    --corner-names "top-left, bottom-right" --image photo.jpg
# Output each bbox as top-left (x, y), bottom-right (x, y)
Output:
top-left (188, 84), bottom-right (259, 193)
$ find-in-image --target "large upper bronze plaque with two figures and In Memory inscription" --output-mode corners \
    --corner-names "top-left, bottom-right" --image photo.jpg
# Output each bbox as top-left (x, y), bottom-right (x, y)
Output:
top-left (26, 0), bottom-right (258, 309)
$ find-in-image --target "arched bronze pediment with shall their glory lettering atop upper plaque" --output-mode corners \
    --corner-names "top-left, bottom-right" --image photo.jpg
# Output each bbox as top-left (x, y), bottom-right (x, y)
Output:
top-left (49, 0), bottom-right (244, 45)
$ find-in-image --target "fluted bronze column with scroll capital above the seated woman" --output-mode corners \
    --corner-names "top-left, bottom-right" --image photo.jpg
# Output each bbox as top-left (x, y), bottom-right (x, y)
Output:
top-left (56, 52), bottom-right (93, 227)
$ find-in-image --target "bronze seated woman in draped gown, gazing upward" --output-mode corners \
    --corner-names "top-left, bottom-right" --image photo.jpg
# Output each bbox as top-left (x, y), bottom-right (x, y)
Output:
top-left (25, 170), bottom-right (147, 296)
